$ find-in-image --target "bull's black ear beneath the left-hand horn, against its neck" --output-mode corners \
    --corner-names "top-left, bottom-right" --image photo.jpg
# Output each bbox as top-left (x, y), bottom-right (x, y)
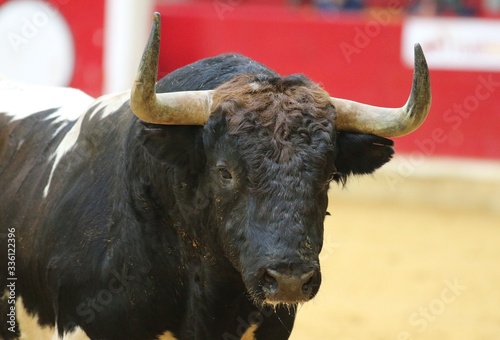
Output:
top-left (137, 122), bottom-right (204, 167)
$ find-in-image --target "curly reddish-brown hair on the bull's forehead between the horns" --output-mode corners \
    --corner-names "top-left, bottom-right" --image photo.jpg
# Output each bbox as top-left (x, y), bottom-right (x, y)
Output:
top-left (213, 75), bottom-right (335, 161)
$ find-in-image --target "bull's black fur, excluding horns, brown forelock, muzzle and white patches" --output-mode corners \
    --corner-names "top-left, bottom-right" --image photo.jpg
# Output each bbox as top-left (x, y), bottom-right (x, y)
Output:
top-left (0, 55), bottom-right (393, 340)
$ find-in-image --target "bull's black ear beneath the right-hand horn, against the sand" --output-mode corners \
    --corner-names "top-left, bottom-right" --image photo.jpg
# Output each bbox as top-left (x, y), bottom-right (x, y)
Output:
top-left (335, 132), bottom-right (394, 182)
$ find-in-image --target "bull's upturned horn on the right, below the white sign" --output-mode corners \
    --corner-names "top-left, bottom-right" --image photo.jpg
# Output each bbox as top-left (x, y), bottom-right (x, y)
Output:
top-left (331, 44), bottom-right (432, 137)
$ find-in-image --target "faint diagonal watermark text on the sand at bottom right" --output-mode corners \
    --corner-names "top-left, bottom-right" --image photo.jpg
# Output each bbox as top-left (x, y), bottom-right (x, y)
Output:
top-left (397, 278), bottom-right (467, 340)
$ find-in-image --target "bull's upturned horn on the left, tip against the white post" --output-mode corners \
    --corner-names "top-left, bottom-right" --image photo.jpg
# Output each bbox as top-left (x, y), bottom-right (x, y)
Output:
top-left (130, 13), bottom-right (213, 125)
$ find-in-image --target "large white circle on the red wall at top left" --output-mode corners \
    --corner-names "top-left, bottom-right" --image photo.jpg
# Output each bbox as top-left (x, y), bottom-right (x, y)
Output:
top-left (0, 0), bottom-right (75, 86)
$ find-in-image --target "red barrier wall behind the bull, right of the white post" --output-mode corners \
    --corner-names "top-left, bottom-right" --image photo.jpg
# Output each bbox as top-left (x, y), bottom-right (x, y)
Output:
top-left (157, 0), bottom-right (500, 159)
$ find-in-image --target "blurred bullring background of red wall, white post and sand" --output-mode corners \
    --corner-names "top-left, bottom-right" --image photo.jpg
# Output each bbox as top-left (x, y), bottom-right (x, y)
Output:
top-left (0, 0), bottom-right (500, 340)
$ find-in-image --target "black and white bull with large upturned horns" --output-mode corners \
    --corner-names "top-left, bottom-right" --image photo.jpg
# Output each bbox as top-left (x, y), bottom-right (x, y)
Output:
top-left (0, 14), bottom-right (431, 339)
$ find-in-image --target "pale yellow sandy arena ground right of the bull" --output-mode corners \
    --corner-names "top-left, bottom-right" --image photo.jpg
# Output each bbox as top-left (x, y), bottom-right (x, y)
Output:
top-left (291, 158), bottom-right (500, 340)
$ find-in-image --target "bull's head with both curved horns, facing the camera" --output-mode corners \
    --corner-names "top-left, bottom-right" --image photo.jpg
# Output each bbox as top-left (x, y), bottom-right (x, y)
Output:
top-left (131, 14), bottom-right (431, 304)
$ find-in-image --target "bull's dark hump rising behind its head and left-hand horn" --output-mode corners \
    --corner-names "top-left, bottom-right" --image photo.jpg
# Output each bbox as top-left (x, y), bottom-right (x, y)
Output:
top-left (157, 53), bottom-right (277, 92)
